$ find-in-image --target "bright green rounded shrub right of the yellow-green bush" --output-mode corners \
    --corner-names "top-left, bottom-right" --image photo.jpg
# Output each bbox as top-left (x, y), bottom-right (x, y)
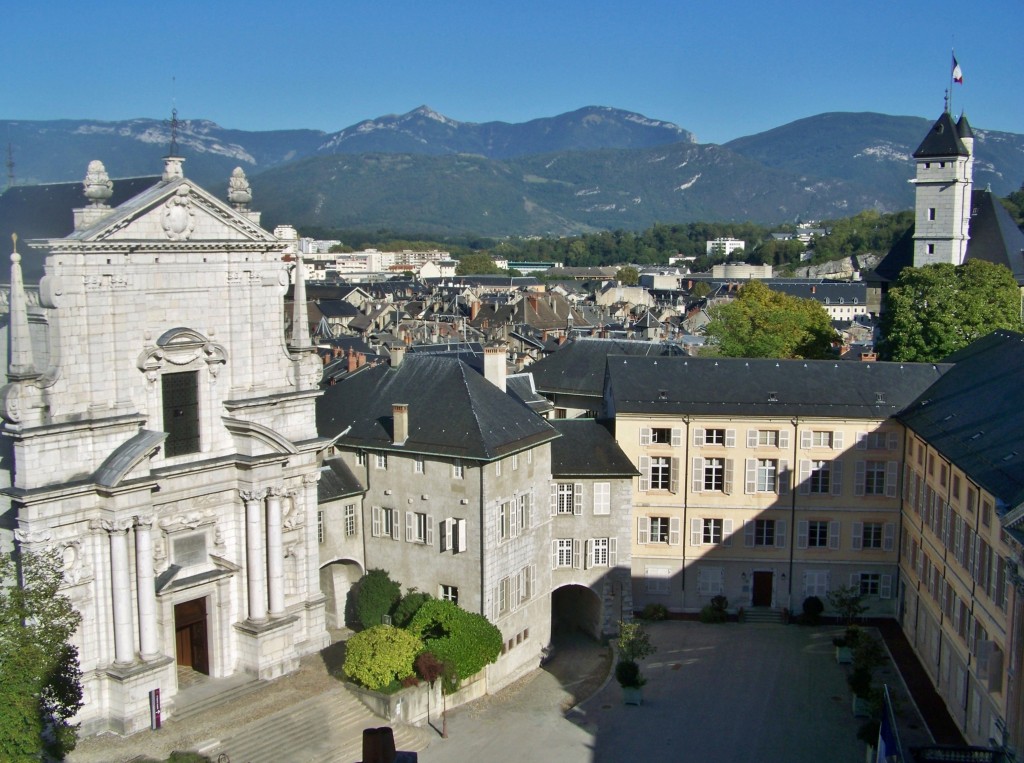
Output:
top-left (409, 599), bottom-right (503, 681)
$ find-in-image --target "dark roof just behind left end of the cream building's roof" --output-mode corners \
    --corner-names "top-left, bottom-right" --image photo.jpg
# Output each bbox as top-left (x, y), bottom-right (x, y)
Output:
top-left (529, 337), bottom-right (682, 397)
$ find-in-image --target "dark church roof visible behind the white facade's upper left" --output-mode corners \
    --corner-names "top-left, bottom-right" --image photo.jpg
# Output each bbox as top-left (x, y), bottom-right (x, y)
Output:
top-left (0, 175), bottom-right (161, 284)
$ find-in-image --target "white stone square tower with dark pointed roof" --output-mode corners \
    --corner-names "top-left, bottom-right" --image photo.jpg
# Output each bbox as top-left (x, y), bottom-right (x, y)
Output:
top-left (911, 111), bottom-right (974, 267)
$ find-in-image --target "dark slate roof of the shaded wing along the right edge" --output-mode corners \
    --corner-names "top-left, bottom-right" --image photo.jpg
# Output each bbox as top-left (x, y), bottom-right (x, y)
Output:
top-left (898, 330), bottom-right (1024, 514)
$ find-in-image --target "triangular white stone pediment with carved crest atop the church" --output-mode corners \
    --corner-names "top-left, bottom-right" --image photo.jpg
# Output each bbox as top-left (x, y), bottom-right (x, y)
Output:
top-left (69, 178), bottom-right (278, 244)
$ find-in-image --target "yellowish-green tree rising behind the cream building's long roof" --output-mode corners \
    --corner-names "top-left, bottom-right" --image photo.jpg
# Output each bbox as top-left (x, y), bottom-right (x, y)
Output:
top-left (705, 281), bottom-right (836, 358)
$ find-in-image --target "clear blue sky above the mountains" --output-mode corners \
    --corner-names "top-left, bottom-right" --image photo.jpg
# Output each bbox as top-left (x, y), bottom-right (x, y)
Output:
top-left (0, 0), bottom-right (1024, 142)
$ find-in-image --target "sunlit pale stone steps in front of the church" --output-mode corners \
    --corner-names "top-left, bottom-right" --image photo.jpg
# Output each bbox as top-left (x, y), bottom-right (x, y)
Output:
top-left (209, 687), bottom-right (434, 763)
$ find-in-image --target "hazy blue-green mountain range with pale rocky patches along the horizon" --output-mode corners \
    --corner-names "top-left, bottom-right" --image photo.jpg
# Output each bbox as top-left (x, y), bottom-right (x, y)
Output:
top-left (0, 107), bottom-right (1024, 236)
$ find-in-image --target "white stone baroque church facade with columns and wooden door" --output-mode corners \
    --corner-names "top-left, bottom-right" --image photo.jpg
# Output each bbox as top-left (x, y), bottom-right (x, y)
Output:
top-left (0, 157), bottom-right (329, 733)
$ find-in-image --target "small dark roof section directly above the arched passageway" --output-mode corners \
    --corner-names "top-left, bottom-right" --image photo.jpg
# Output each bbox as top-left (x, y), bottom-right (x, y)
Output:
top-left (551, 419), bottom-right (640, 479)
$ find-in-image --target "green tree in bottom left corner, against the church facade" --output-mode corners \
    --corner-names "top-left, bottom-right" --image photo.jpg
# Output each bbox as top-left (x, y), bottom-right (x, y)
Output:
top-left (0, 553), bottom-right (82, 761)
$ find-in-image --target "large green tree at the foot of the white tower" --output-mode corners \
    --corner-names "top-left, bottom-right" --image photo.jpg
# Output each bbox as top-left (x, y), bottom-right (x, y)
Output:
top-left (880, 260), bottom-right (1021, 363)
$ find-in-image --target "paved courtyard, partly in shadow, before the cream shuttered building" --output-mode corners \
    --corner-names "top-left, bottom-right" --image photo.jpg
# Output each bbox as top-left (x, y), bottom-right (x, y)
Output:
top-left (420, 622), bottom-right (864, 763)
